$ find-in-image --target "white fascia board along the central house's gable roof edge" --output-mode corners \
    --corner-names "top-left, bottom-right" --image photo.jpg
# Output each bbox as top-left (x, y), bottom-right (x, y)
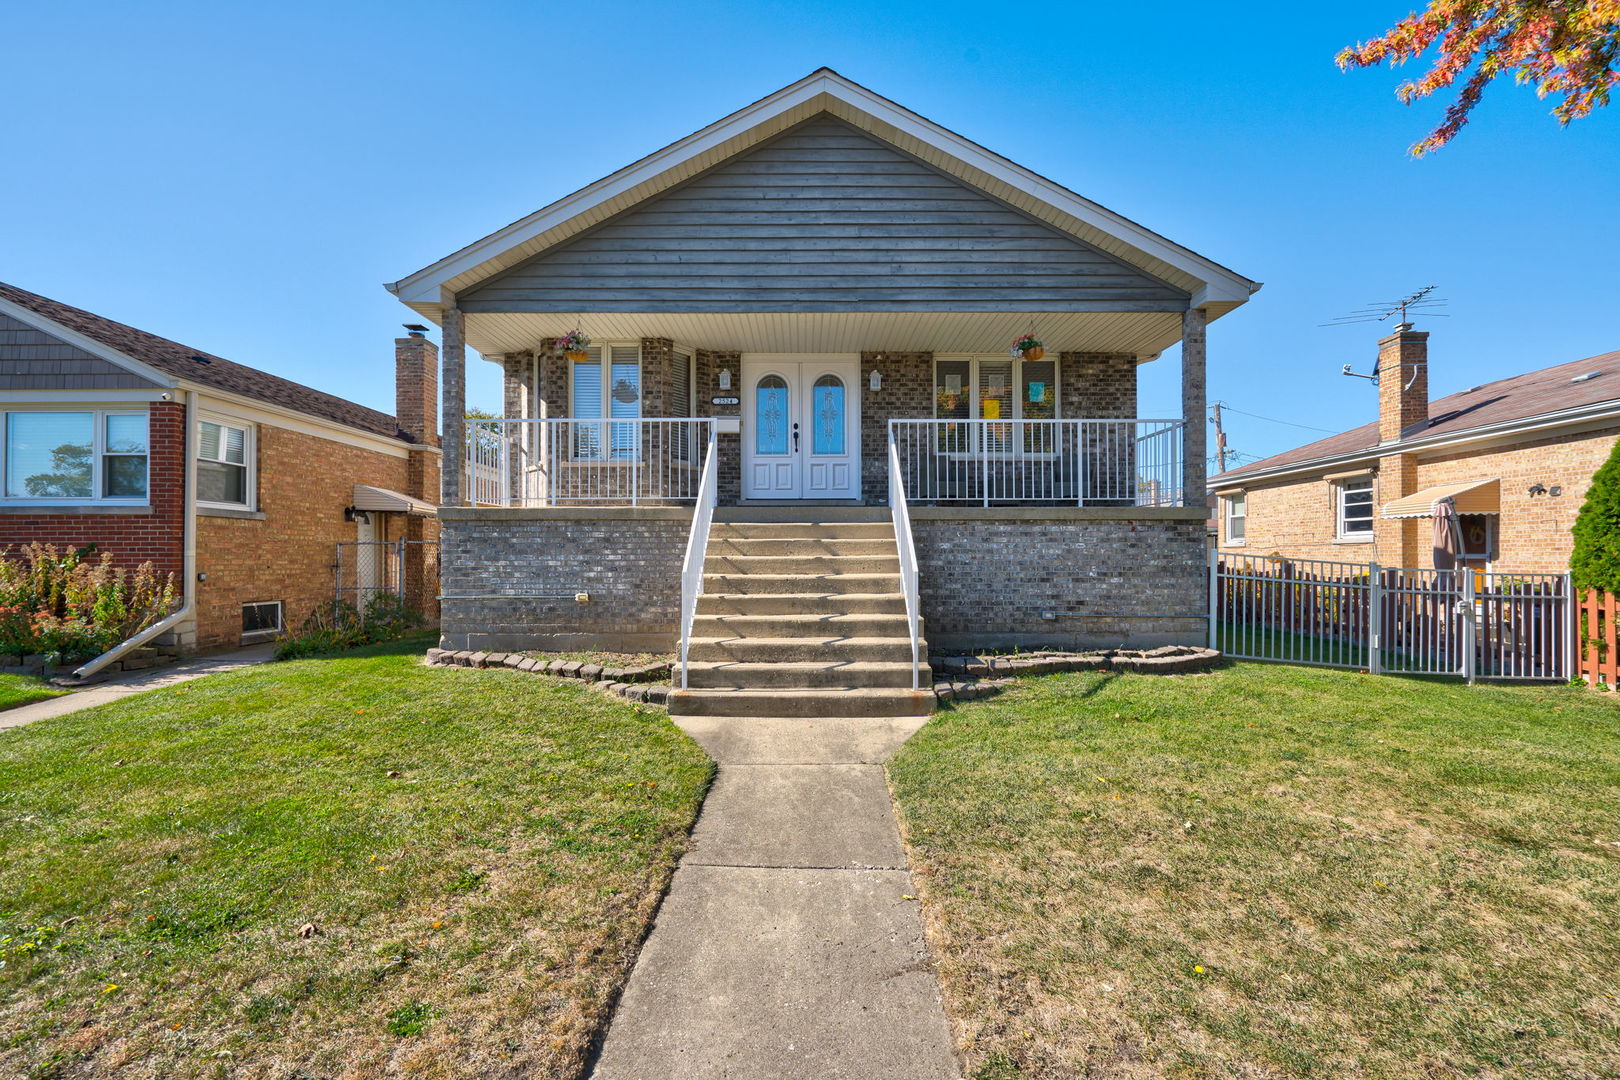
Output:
top-left (386, 70), bottom-right (1260, 311)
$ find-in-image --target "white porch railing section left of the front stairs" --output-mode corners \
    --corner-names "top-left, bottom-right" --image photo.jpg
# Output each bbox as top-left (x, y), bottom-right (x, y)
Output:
top-left (467, 418), bottom-right (714, 507)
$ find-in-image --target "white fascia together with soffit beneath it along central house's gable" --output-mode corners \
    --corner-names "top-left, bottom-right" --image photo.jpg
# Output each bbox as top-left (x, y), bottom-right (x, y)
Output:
top-left (387, 68), bottom-right (1259, 321)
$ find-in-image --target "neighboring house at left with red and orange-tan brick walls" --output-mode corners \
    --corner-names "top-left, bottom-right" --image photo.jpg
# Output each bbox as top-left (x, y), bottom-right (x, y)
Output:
top-left (0, 283), bottom-right (439, 651)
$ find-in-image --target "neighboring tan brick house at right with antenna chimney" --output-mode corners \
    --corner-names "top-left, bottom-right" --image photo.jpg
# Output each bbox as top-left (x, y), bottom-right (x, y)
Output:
top-left (1210, 325), bottom-right (1620, 573)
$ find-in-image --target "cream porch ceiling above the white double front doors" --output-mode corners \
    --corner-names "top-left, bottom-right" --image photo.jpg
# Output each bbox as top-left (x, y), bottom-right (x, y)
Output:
top-left (465, 311), bottom-right (1181, 359)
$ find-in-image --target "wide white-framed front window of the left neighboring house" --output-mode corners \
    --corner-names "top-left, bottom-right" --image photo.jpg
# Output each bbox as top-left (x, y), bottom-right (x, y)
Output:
top-left (0, 410), bottom-right (149, 502)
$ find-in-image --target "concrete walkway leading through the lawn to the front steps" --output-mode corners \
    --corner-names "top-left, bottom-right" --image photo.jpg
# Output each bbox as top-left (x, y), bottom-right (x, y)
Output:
top-left (591, 716), bottom-right (961, 1080)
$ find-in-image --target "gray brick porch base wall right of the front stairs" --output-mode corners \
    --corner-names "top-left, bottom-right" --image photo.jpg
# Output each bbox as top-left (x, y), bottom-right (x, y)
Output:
top-left (912, 508), bottom-right (1209, 653)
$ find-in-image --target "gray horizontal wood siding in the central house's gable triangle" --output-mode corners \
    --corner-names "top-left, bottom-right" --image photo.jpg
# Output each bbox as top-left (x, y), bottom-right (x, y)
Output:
top-left (457, 115), bottom-right (1187, 313)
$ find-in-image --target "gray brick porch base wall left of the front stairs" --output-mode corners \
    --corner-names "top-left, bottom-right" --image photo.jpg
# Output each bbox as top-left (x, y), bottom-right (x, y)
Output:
top-left (441, 508), bottom-right (692, 651)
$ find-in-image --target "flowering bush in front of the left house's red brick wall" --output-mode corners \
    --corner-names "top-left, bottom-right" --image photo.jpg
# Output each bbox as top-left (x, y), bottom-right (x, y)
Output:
top-left (0, 544), bottom-right (175, 661)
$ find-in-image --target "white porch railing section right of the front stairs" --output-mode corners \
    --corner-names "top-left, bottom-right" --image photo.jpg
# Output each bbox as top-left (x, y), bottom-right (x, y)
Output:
top-left (889, 419), bottom-right (1186, 507)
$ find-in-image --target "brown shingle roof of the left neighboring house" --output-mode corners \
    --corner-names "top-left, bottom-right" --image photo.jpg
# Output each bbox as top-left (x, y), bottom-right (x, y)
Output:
top-left (0, 282), bottom-right (410, 442)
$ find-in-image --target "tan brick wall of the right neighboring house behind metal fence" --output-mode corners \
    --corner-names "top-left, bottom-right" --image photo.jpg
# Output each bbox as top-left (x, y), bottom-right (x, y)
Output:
top-left (1220, 426), bottom-right (1620, 573)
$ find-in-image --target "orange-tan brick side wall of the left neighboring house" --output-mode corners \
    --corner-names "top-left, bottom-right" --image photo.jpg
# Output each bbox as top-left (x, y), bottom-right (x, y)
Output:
top-left (196, 424), bottom-right (437, 649)
